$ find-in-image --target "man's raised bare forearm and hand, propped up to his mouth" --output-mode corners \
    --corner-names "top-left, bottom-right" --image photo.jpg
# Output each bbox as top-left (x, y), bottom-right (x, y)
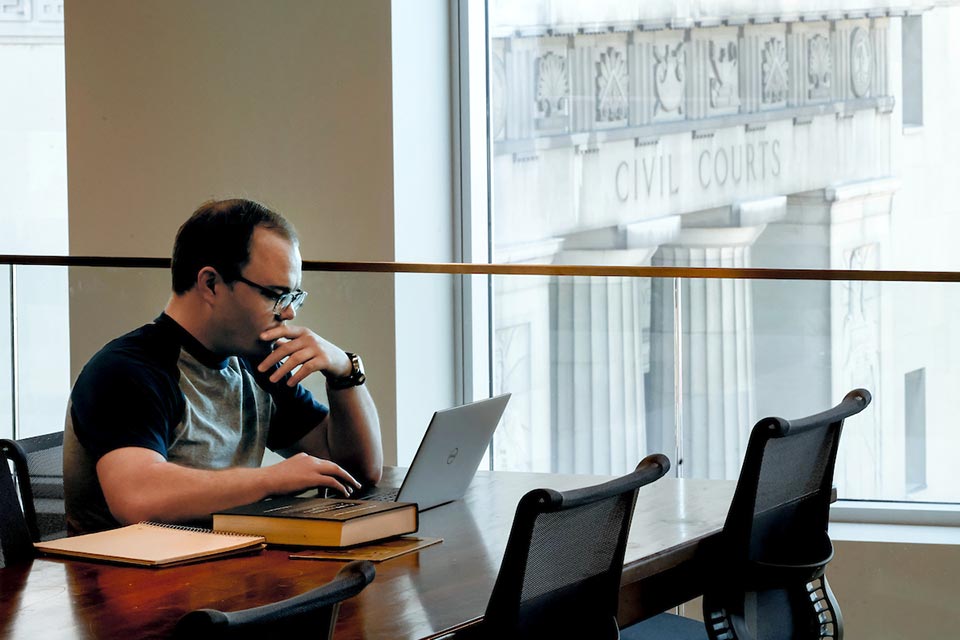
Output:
top-left (257, 325), bottom-right (383, 484)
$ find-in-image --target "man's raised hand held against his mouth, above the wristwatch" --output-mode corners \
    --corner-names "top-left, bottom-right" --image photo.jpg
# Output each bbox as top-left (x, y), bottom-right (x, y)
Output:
top-left (257, 325), bottom-right (352, 387)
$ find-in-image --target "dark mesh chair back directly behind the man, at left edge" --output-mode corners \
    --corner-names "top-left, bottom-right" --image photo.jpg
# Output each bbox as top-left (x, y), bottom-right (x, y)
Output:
top-left (0, 431), bottom-right (67, 542)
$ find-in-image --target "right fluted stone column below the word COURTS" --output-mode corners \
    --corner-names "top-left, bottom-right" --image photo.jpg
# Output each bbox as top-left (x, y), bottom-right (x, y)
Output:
top-left (647, 197), bottom-right (786, 478)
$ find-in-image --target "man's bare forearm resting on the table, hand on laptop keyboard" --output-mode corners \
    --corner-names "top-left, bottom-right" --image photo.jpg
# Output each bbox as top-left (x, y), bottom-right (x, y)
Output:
top-left (97, 447), bottom-right (360, 524)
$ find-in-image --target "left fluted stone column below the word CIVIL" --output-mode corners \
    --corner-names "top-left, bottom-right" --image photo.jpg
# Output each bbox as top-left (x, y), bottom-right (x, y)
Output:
top-left (550, 217), bottom-right (679, 474)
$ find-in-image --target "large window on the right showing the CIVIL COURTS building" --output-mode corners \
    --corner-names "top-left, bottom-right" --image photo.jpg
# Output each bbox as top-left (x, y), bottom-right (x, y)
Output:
top-left (484, 0), bottom-right (960, 501)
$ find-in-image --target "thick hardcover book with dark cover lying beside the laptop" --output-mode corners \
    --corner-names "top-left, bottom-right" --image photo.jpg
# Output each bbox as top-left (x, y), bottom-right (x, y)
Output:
top-left (213, 497), bottom-right (420, 547)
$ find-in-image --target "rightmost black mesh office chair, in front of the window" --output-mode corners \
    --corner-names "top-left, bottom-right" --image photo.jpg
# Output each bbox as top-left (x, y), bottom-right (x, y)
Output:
top-left (703, 389), bottom-right (871, 640)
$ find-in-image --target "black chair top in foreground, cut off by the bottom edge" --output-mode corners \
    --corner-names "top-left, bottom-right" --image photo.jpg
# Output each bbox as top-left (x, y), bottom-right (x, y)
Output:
top-left (174, 560), bottom-right (376, 640)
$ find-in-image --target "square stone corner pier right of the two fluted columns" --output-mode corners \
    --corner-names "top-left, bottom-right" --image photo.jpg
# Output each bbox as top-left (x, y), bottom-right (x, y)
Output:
top-left (754, 178), bottom-right (903, 498)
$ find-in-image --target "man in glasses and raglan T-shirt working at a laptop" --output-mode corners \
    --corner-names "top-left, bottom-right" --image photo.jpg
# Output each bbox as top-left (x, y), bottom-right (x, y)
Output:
top-left (64, 200), bottom-right (383, 534)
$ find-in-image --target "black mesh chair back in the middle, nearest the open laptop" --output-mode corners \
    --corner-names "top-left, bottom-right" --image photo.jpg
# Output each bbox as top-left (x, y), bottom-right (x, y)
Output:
top-left (483, 454), bottom-right (670, 638)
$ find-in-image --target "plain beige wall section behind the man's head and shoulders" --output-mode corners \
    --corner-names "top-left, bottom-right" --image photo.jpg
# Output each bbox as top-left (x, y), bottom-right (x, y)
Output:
top-left (65, 0), bottom-right (460, 462)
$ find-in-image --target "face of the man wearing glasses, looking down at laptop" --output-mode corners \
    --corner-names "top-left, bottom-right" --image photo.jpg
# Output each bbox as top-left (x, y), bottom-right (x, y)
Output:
top-left (217, 227), bottom-right (302, 364)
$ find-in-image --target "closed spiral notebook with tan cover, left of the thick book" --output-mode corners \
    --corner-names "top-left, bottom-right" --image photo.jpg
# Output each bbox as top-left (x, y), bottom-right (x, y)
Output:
top-left (34, 522), bottom-right (266, 567)
